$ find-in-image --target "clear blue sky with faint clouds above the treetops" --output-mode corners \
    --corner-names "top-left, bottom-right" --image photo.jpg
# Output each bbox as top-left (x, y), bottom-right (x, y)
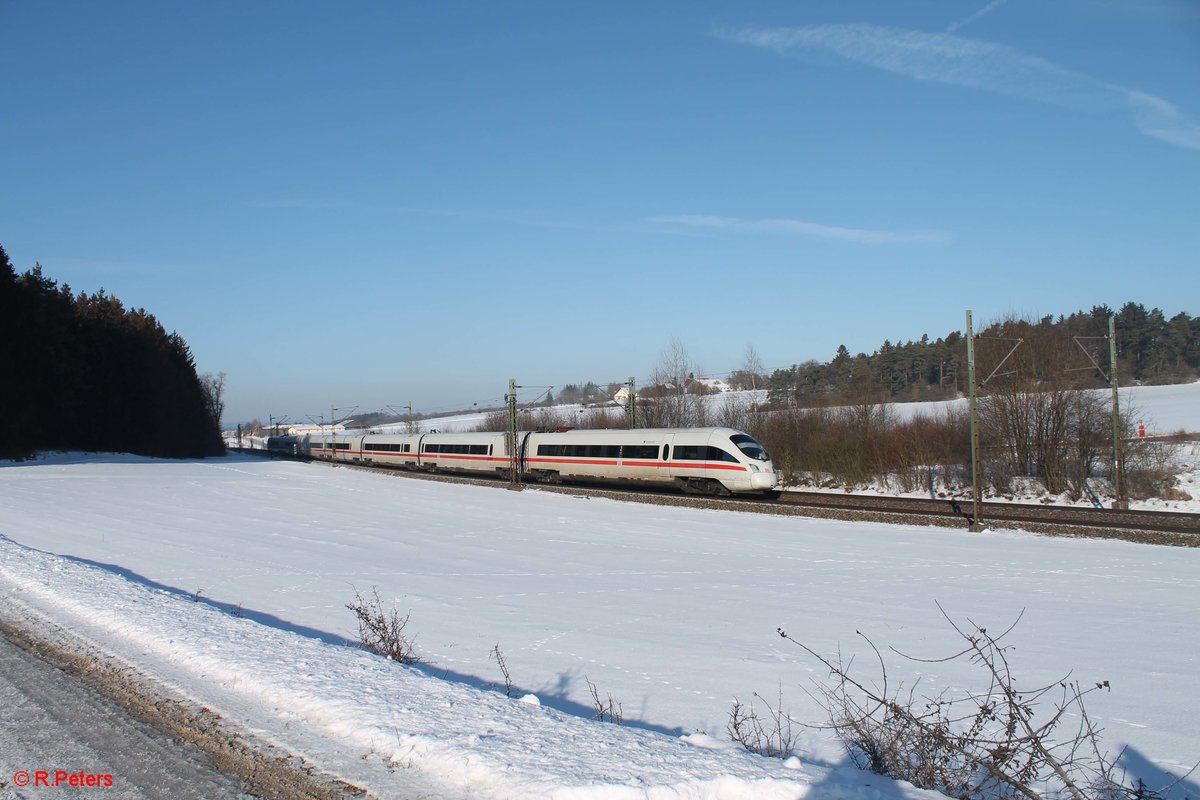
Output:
top-left (0, 0), bottom-right (1200, 421)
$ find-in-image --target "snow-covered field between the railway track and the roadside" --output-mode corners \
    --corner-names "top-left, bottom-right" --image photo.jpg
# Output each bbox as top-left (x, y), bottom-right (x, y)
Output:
top-left (0, 456), bottom-right (1200, 799)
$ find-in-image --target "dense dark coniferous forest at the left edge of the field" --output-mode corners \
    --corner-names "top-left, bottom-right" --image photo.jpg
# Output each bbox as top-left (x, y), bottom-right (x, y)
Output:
top-left (0, 241), bottom-right (224, 458)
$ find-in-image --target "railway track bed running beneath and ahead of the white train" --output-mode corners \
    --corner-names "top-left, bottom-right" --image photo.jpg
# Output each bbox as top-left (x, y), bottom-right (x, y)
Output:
top-left (234, 450), bottom-right (1200, 547)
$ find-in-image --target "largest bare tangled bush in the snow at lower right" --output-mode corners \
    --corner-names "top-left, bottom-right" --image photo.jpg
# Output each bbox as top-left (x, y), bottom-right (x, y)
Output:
top-left (778, 606), bottom-right (1185, 800)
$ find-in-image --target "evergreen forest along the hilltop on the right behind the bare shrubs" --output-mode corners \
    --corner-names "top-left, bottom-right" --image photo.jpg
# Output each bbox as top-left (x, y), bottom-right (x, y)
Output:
top-left (763, 302), bottom-right (1200, 407)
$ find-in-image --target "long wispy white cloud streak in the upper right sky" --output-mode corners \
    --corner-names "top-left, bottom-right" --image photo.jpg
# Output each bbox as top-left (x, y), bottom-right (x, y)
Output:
top-left (716, 23), bottom-right (1200, 150)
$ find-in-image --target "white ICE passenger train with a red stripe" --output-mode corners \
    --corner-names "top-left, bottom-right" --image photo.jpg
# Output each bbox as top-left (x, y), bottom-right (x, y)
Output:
top-left (268, 428), bottom-right (779, 495)
